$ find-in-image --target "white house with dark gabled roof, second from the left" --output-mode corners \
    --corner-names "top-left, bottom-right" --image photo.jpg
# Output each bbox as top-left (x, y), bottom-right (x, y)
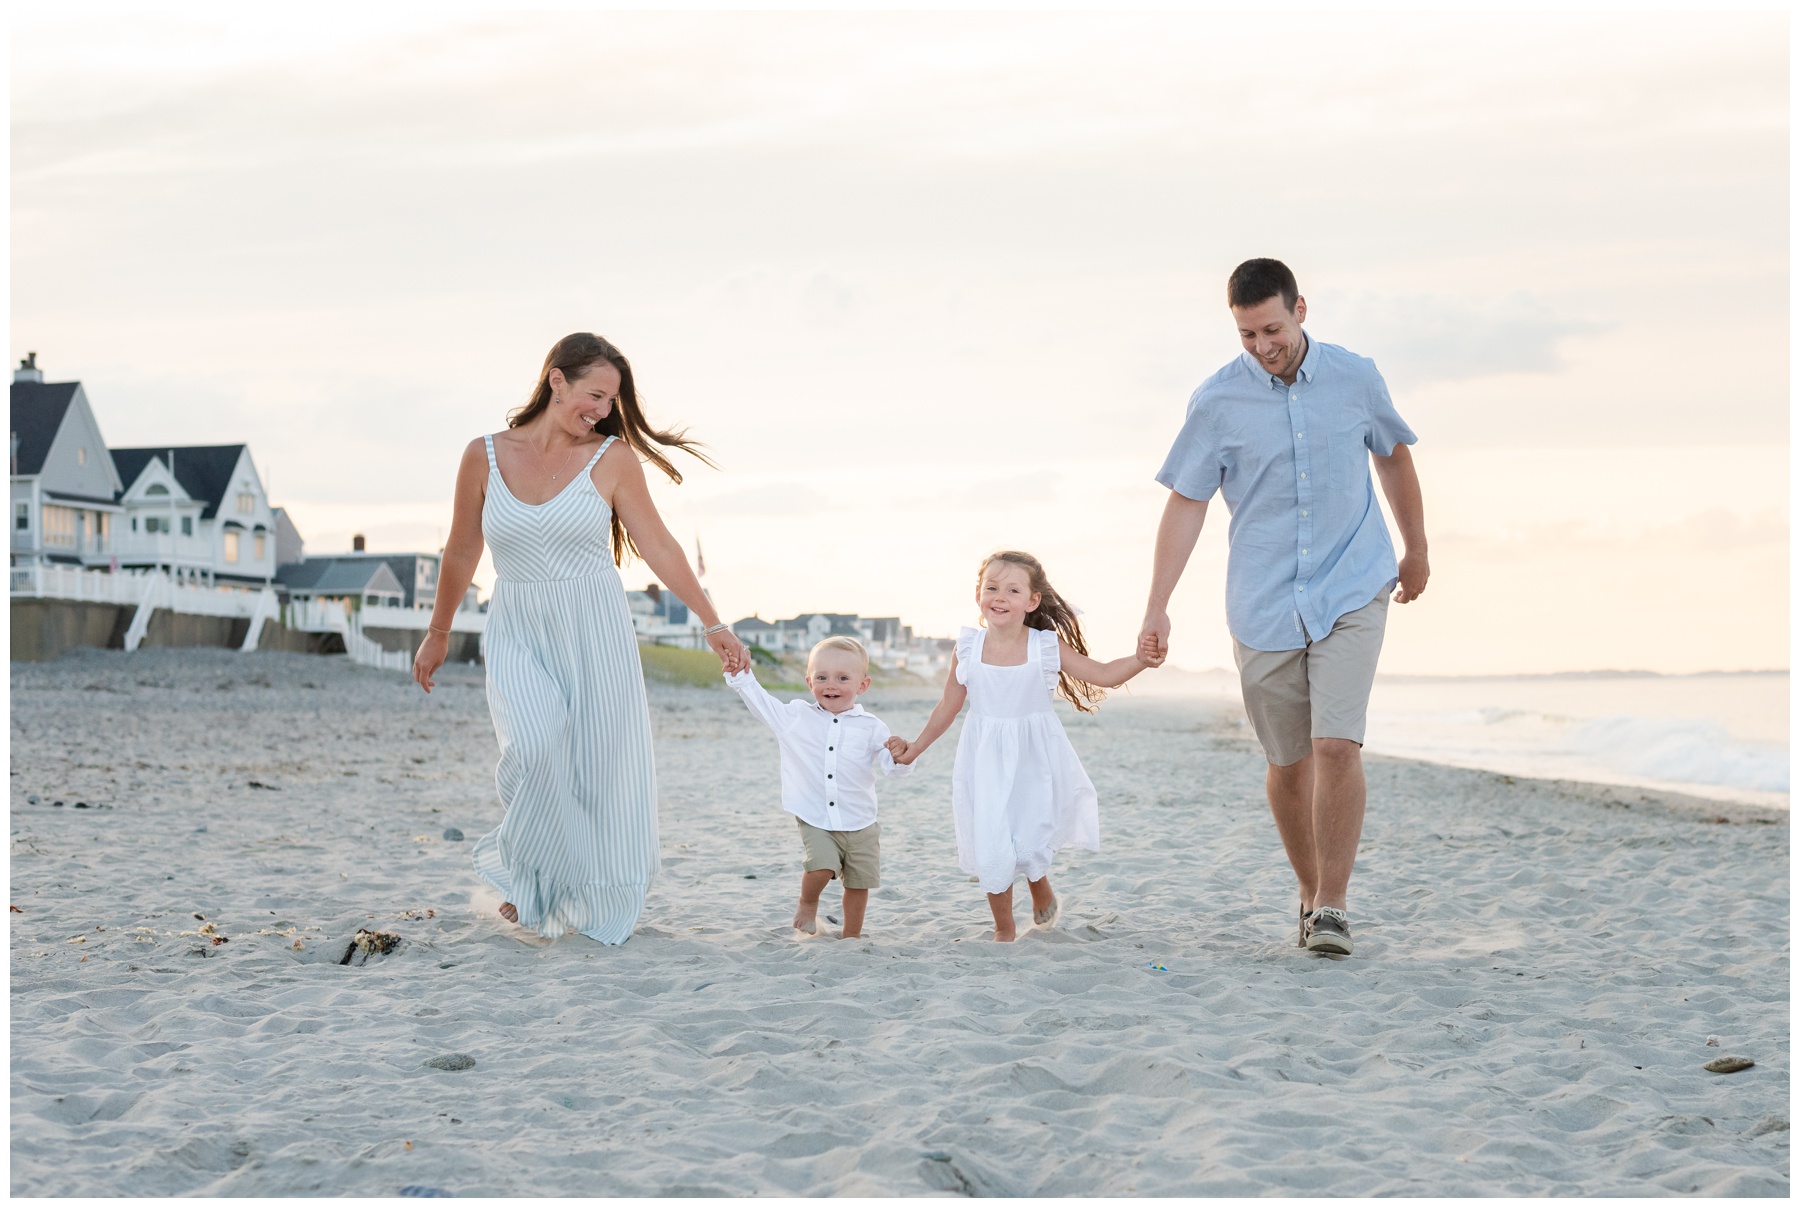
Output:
top-left (112, 445), bottom-right (275, 587)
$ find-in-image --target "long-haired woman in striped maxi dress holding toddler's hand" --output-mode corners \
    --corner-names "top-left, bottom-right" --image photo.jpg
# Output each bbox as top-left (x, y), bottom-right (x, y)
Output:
top-left (412, 333), bottom-right (749, 943)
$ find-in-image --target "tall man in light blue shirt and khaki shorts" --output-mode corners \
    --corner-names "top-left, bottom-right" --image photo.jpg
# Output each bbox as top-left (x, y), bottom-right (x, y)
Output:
top-left (1139, 259), bottom-right (1431, 956)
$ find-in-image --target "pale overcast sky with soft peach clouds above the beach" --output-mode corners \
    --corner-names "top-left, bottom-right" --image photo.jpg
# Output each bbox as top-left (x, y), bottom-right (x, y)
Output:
top-left (11, 4), bottom-right (1787, 673)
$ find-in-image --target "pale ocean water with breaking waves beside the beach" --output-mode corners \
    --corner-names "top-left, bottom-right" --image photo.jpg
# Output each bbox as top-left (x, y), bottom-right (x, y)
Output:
top-left (1156, 672), bottom-right (1789, 808)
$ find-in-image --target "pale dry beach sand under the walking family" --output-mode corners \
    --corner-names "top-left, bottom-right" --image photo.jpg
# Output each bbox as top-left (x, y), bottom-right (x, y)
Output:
top-left (11, 650), bottom-right (1789, 1195)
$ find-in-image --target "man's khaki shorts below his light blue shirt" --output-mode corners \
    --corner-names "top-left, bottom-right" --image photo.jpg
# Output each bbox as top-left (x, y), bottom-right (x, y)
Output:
top-left (1233, 589), bottom-right (1388, 767)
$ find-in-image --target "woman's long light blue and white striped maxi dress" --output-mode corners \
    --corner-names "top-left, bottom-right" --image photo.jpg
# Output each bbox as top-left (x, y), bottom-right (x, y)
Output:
top-left (473, 436), bottom-right (657, 943)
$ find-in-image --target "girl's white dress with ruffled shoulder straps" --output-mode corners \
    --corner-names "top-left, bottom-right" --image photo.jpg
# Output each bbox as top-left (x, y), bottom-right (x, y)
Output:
top-left (950, 628), bottom-right (1100, 893)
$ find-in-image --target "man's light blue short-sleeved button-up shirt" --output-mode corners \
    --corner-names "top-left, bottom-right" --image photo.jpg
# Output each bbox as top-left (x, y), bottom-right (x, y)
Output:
top-left (1156, 338), bottom-right (1418, 650)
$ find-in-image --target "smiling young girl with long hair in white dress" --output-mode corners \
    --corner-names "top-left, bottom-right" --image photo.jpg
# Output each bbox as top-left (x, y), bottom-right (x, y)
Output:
top-left (887, 551), bottom-right (1161, 943)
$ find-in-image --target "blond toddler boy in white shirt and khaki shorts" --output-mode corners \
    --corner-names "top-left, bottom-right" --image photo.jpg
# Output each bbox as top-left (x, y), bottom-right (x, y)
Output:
top-left (725, 637), bottom-right (913, 940)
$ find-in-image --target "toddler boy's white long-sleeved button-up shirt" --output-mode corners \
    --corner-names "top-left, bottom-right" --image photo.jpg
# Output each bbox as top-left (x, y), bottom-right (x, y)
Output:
top-left (725, 672), bottom-right (913, 830)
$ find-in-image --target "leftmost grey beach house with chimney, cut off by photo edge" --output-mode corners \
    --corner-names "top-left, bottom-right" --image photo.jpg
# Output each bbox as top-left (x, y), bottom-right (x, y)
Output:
top-left (11, 353), bottom-right (122, 567)
